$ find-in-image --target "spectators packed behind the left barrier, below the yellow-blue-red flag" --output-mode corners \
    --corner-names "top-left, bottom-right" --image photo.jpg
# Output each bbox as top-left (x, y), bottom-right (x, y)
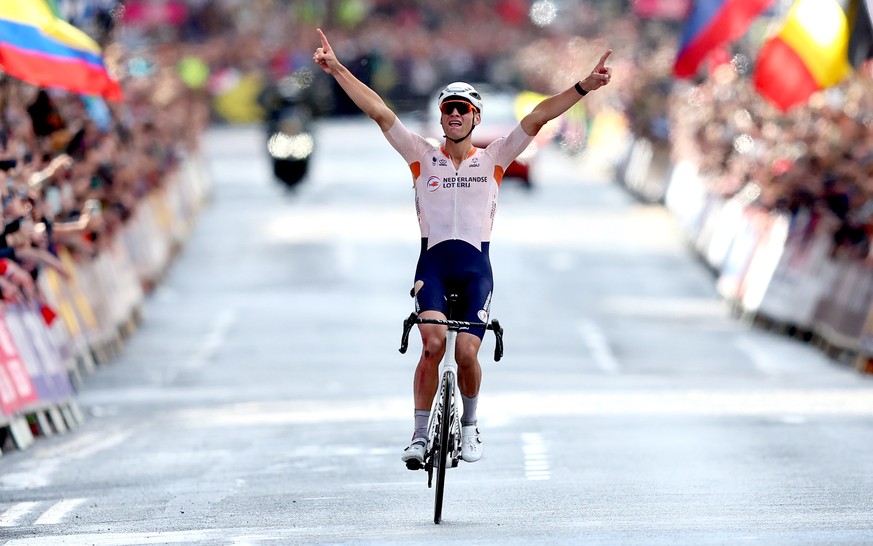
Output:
top-left (0, 15), bottom-right (209, 310)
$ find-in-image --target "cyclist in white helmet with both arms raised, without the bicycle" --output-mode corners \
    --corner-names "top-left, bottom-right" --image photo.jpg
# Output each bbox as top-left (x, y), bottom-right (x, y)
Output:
top-left (312, 29), bottom-right (612, 469)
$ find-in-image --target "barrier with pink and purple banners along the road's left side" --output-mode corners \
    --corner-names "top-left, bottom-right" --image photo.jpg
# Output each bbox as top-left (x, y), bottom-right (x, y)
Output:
top-left (0, 151), bottom-right (210, 449)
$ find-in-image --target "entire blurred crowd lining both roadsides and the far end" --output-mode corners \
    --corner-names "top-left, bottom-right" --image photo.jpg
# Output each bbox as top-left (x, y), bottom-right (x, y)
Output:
top-left (0, 0), bottom-right (873, 314)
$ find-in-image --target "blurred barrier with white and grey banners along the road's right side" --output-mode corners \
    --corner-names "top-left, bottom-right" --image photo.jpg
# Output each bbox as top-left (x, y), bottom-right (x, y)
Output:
top-left (616, 137), bottom-right (873, 373)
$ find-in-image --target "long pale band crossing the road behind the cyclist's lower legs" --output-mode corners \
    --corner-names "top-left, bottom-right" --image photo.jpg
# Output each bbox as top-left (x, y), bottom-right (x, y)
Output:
top-left (169, 387), bottom-right (873, 428)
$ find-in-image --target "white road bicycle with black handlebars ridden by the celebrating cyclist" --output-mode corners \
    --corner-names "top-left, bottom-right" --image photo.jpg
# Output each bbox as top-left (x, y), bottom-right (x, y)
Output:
top-left (400, 294), bottom-right (503, 523)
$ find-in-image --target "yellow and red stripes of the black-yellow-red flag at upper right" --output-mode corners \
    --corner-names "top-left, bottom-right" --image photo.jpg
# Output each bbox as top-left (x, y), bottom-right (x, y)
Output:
top-left (752, 0), bottom-right (852, 111)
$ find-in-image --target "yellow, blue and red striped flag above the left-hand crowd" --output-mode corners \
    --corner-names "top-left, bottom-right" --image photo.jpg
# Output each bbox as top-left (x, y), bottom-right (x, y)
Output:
top-left (0, 0), bottom-right (122, 101)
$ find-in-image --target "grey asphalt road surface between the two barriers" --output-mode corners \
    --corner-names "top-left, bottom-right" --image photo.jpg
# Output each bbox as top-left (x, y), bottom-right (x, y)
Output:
top-left (0, 120), bottom-right (873, 546)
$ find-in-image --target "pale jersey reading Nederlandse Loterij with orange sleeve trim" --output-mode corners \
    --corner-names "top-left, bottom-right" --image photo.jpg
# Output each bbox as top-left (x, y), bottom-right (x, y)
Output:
top-left (385, 119), bottom-right (533, 250)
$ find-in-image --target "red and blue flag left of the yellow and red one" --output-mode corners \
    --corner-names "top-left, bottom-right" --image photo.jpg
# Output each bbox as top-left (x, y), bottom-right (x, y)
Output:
top-left (673, 0), bottom-right (773, 78)
